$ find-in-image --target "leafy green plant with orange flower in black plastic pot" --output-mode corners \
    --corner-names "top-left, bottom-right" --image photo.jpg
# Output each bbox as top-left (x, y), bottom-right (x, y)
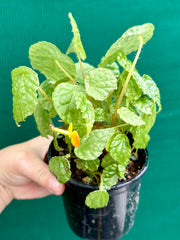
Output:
top-left (12, 13), bottom-right (161, 239)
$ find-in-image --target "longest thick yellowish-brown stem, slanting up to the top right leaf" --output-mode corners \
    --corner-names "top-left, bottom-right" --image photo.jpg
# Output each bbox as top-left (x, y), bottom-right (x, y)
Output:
top-left (111, 36), bottom-right (143, 126)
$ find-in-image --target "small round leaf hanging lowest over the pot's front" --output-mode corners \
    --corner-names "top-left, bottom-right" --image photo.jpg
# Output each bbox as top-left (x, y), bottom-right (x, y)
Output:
top-left (85, 190), bottom-right (109, 209)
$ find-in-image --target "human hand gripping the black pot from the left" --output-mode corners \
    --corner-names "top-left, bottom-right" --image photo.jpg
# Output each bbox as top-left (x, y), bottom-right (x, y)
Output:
top-left (0, 137), bottom-right (65, 213)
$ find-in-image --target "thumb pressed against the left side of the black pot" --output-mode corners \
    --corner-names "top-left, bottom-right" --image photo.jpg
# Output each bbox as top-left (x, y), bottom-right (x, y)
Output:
top-left (18, 152), bottom-right (65, 195)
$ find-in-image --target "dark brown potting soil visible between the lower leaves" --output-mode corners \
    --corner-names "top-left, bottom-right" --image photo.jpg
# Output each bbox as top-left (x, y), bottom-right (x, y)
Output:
top-left (46, 136), bottom-right (145, 185)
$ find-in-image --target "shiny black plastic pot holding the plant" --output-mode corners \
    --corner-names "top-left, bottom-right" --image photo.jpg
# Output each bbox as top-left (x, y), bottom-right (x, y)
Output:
top-left (49, 142), bottom-right (149, 240)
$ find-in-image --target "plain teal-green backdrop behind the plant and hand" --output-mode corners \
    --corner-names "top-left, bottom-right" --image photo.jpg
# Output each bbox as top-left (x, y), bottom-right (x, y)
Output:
top-left (0, 0), bottom-right (180, 240)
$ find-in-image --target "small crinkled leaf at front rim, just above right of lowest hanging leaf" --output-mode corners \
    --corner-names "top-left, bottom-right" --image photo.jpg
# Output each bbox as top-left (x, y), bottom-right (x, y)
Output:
top-left (101, 164), bottom-right (119, 190)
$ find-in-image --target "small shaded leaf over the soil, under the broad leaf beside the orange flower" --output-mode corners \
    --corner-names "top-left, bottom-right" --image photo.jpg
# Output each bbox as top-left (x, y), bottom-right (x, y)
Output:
top-left (74, 159), bottom-right (100, 172)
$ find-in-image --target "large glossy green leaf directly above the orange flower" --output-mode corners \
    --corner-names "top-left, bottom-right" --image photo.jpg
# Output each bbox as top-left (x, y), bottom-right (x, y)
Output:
top-left (52, 83), bottom-right (83, 124)
